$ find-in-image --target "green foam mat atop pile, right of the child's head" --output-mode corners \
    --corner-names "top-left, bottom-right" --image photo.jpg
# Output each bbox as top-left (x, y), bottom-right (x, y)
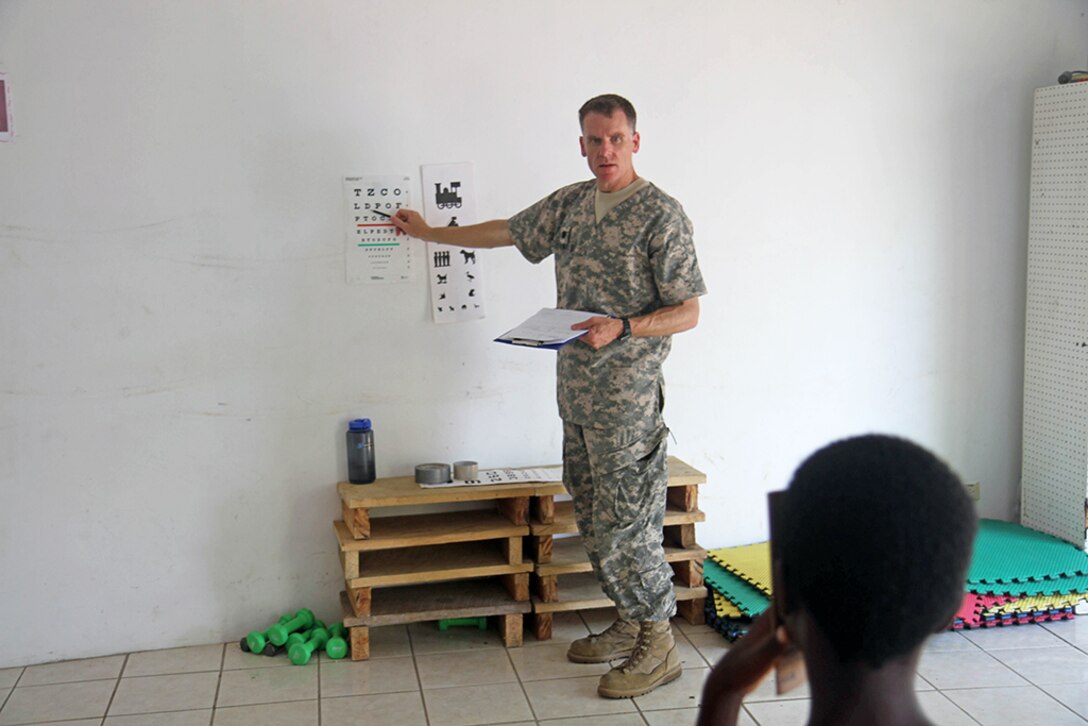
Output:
top-left (967, 519), bottom-right (1088, 592)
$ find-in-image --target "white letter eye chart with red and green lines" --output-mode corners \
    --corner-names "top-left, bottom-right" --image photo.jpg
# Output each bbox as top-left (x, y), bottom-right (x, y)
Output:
top-left (344, 176), bottom-right (416, 285)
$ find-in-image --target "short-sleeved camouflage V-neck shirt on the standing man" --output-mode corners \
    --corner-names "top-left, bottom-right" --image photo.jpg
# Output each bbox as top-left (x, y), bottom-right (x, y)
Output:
top-left (509, 180), bottom-right (706, 428)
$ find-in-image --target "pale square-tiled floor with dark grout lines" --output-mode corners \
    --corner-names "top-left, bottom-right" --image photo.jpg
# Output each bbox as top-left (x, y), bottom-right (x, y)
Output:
top-left (0, 611), bottom-right (1088, 726)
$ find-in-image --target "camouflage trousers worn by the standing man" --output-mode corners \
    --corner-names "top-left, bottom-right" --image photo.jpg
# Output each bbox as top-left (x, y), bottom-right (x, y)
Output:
top-left (562, 421), bottom-right (677, 622)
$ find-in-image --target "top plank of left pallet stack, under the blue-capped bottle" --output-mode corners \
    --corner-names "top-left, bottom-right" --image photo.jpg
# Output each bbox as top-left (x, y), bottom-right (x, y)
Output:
top-left (336, 465), bottom-right (564, 509)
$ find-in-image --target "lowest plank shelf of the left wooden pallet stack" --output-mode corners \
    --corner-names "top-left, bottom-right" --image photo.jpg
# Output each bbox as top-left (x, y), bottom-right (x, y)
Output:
top-left (341, 578), bottom-right (532, 628)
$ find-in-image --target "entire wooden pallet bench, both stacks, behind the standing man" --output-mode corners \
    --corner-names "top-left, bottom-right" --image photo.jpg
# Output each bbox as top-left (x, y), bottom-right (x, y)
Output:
top-left (333, 457), bottom-right (706, 661)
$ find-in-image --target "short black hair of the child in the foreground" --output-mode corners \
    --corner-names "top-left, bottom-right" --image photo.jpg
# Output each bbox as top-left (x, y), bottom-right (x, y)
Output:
top-left (776, 434), bottom-right (978, 668)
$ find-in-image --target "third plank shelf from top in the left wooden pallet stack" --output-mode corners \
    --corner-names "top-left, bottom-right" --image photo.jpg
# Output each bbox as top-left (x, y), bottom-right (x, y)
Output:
top-left (347, 541), bottom-right (533, 588)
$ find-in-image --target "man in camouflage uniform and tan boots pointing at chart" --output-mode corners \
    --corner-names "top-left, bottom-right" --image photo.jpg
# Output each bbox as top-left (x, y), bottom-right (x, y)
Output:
top-left (394, 95), bottom-right (706, 698)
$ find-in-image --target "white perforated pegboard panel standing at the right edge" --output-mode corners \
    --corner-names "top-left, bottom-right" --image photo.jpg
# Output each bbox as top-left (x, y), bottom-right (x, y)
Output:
top-left (1021, 83), bottom-right (1088, 546)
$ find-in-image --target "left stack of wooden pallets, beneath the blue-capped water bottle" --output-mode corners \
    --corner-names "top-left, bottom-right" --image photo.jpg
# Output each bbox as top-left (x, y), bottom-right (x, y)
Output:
top-left (334, 477), bottom-right (562, 661)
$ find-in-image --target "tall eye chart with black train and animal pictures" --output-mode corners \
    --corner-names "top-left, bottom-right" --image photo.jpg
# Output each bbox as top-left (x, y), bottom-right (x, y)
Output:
top-left (421, 163), bottom-right (484, 322)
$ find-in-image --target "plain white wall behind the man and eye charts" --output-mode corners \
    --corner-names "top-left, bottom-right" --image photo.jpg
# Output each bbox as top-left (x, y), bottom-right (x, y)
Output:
top-left (0, 0), bottom-right (1088, 666)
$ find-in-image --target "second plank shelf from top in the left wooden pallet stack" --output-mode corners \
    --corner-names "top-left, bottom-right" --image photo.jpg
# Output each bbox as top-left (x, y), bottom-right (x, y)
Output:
top-left (333, 507), bottom-right (529, 552)
